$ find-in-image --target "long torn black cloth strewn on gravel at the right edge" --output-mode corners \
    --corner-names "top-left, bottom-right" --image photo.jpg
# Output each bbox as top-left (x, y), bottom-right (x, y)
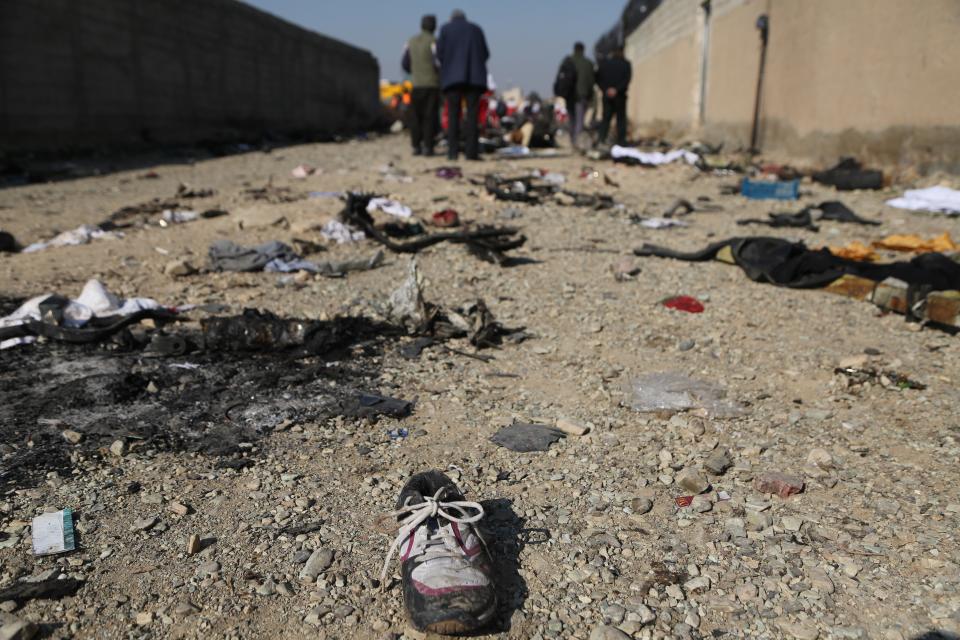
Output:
top-left (634, 236), bottom-right (960, 291)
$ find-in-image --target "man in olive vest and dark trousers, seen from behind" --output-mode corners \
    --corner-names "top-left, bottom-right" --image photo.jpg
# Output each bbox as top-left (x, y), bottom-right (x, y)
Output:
top-left (401, 15), bottom-right (440, 156)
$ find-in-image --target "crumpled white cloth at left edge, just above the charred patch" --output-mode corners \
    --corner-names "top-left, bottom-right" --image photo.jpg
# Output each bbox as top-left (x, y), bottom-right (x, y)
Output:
top-left (0, 280), bottom-right (162, 349)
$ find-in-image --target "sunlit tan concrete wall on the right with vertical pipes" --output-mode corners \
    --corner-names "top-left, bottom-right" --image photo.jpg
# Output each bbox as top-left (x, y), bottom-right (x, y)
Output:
top-left (626, 0), bottom-right (960, 173)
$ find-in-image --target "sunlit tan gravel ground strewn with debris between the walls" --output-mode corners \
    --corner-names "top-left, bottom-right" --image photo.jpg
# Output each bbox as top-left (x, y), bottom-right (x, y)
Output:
top-left (0, 132), bottom-right (960, 640)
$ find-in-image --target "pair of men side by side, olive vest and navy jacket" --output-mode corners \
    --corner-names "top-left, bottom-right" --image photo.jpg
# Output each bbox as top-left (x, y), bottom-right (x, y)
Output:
top-left (402, 9), bottom-right (490, 160)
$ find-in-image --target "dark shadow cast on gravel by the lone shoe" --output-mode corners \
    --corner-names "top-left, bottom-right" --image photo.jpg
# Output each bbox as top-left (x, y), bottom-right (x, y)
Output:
top-left (481, 498), bottom-right (550, 633)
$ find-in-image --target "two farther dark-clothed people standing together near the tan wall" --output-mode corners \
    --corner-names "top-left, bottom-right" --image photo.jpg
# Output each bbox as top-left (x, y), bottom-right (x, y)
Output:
top-left (553, 42), bottom-right (633, 147)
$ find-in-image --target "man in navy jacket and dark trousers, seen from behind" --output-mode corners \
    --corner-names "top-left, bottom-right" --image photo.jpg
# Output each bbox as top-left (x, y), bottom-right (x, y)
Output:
top-left (437, 9), bottom-right (490, 160)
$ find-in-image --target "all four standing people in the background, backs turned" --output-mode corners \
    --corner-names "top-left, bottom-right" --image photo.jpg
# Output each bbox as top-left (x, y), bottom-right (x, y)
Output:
top-left (401, 9), bottom-right (631, 160)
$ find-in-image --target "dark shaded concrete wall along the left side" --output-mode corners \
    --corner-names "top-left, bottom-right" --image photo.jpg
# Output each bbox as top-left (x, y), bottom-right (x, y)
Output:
top-left (0, 0), bottom-right (379, 150)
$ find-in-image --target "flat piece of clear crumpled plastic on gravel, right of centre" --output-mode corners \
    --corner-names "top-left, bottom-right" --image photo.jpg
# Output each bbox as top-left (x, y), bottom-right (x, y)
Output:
top-left (624, 372), bottom-right (744, 418)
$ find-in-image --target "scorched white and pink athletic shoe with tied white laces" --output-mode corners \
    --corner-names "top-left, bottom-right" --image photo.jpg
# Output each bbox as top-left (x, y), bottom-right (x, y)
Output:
top-left (380, 471), bottom-right (497, 635)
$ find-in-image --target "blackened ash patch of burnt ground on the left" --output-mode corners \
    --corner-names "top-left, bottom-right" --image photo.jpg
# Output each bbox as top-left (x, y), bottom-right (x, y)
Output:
top-left (0, 320), bottom-right (404, 486)
